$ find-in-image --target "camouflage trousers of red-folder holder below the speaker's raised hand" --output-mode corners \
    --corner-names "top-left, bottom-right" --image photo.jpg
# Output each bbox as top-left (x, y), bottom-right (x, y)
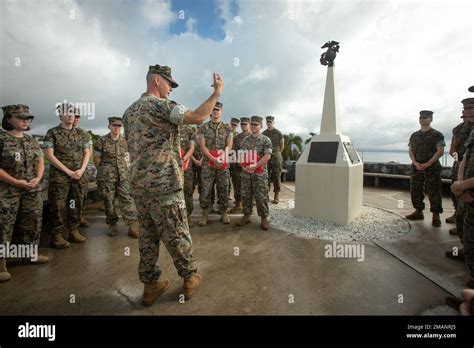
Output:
top-left (199, 164), bottom-right (230, 212)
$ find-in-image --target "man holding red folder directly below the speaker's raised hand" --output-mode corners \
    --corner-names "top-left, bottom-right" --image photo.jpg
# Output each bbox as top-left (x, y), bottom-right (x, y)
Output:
top-left (199, 102), bottom-right (233, 226)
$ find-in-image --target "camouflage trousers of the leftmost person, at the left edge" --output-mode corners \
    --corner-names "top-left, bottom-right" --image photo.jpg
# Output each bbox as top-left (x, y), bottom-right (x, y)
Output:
top-left (0, 187), bottom-right (43, 244)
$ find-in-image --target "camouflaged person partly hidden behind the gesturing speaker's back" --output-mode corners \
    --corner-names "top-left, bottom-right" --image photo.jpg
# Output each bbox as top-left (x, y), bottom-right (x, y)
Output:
top-left (179, 125), bottom-right (196, 227)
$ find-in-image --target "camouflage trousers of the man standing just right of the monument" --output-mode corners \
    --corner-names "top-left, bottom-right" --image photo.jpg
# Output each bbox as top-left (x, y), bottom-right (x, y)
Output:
top-left (410, 168), bottom-right (443, 214)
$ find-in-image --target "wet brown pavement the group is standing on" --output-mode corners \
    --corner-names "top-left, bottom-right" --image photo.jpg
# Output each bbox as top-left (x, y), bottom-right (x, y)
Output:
top-left (0, 183), bottom-right (462, 315)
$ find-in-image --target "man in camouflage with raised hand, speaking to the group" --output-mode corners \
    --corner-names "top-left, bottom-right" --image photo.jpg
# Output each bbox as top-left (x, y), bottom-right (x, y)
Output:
top-left (123, 65), bottom-right (223, 305)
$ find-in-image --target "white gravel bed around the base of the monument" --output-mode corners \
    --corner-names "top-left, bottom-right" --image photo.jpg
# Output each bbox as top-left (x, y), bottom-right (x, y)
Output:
top-left (268, 200), bottom-right (410, 242)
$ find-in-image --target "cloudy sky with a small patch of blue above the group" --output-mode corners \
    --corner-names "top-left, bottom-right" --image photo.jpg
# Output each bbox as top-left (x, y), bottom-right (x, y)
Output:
top-left (0, 0), bottom-right (474, 149)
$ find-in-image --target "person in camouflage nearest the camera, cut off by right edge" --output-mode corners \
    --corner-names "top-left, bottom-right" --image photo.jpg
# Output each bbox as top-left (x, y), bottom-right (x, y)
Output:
top-left (452, 98), bottom-right (474, 288)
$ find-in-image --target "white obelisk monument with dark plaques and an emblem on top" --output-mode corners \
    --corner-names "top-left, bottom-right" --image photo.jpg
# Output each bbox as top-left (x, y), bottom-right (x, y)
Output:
top-left (295, 41), bottom-right (364, 225)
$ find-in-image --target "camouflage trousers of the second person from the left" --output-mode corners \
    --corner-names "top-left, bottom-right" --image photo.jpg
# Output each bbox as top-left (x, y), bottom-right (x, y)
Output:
top-left (48, 179), bottom-right (87, 234)
